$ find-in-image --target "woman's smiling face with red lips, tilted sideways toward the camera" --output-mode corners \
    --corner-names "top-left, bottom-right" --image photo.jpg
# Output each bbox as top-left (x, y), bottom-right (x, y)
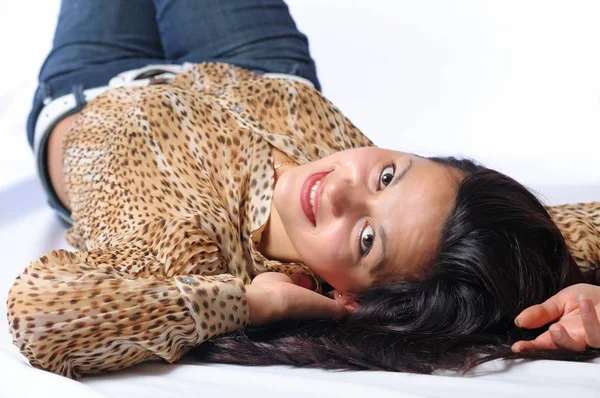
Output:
top-left (273, 147), bottom-right (460, 293)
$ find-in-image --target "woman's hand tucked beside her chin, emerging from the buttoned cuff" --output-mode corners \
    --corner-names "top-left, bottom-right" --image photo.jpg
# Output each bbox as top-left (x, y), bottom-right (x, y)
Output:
top-left (246, 272), bottom-right (348, 326)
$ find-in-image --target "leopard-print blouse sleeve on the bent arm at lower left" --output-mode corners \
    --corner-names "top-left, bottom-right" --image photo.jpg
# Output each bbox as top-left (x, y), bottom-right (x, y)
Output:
top-left (7, 221), bottom-right (249, 378)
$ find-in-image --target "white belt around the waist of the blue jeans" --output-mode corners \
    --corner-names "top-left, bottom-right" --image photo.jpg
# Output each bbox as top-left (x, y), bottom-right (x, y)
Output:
top-left (33, 62), bottom-right (314, 158)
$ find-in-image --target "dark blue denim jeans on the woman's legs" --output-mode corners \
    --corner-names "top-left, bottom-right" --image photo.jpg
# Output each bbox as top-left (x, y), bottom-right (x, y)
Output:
top-left (27, 0), bottom-right (320, 147)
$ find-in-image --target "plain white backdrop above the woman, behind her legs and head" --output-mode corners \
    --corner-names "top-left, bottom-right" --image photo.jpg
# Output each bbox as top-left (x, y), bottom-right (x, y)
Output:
top-left (0, 0), bottom-right (600, 193)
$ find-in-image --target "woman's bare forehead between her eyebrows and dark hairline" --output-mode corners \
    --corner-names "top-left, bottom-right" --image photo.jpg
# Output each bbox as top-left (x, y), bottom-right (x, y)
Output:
top-left (377, 154), bottom-right (461, 281)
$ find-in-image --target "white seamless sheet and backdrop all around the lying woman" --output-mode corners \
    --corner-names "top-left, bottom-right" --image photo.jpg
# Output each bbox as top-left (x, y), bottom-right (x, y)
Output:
top-left (0, 0), bottom-right (600, 398)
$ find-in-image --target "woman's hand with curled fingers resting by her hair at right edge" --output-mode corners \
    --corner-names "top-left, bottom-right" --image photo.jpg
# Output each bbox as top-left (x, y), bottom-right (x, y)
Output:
top-left (512, 283), bottom-right (600, 352)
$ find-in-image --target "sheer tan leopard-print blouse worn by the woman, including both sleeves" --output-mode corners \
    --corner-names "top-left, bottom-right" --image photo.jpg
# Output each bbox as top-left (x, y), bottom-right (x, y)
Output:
top-left (7, 63), bottom-right (600, 378)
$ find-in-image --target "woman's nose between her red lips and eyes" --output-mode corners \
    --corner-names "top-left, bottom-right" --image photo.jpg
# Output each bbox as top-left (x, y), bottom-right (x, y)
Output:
top-left (322, 173), bottom-right (365, 217)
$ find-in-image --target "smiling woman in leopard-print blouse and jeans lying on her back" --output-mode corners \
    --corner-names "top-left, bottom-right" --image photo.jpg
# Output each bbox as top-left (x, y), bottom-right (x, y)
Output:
top-left (8, 0), bottom-right (600, 377)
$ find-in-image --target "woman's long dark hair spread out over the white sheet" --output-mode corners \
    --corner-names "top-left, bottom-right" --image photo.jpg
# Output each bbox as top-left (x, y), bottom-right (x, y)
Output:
top-left (193, 157), bottom-right (598, 373)
